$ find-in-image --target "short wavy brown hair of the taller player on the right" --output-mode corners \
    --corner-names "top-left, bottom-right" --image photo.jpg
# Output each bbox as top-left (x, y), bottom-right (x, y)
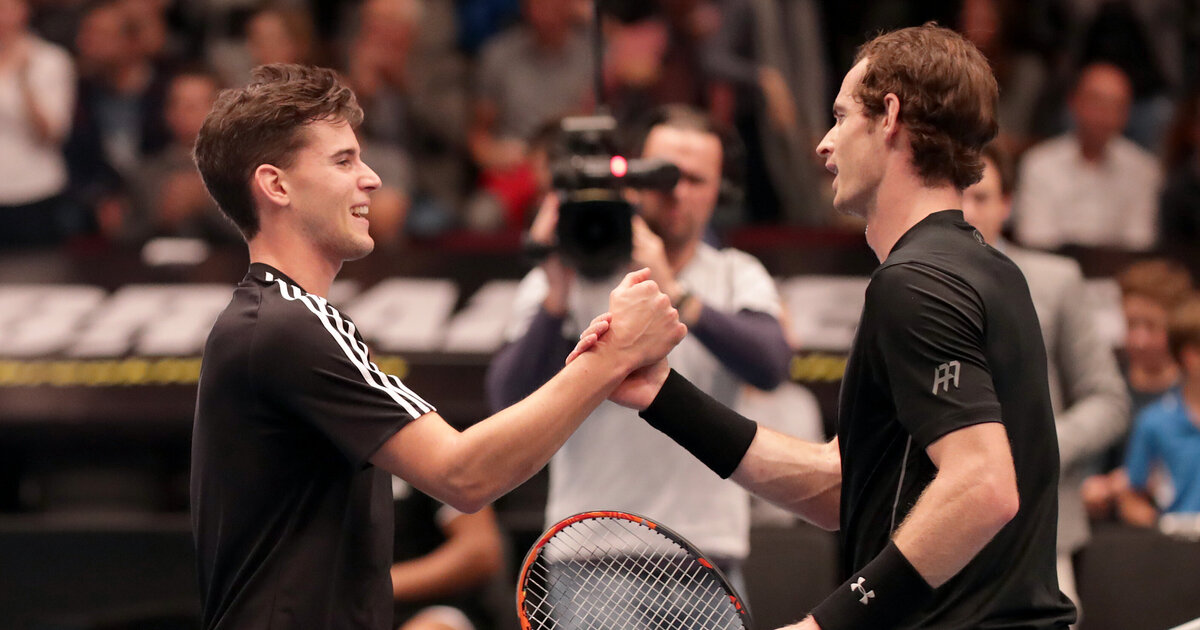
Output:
top-left (854, 23), bottom-right (1000, 191)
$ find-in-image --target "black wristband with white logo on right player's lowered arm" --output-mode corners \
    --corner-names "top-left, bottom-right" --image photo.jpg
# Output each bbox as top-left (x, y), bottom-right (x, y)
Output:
top-left (812, 541), bottom-right (934, 630)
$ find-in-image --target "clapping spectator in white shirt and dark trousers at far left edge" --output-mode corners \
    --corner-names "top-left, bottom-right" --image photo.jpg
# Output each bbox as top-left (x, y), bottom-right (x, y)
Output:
top-left (0, 0), bottom-right (74, 248)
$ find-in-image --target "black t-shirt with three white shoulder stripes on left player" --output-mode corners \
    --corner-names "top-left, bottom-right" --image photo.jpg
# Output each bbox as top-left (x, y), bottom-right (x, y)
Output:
top-left (191, 263), bottom-right (433, 630)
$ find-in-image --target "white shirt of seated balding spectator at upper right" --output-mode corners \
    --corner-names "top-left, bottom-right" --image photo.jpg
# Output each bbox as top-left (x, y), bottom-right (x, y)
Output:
top-left (1014, 134), bottom-right (1163, 251)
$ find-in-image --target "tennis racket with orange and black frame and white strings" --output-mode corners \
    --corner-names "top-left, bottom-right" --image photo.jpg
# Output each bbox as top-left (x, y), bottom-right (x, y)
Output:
top-left (517, 511), bottom-right (751, 630)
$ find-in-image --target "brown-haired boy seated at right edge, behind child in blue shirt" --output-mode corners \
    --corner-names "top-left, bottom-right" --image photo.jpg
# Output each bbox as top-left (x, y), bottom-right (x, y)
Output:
top-left (1081, 258), bottom-right (1192, 520)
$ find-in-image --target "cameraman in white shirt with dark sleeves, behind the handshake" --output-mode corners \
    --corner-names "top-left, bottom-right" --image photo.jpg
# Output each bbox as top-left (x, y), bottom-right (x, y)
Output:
top-left (486, 106), bottom-right (791, 580)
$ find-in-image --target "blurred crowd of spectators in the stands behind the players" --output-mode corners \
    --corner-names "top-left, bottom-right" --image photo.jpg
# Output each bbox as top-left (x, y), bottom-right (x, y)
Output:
top-left (0, 0), bottom-right (1200, 251)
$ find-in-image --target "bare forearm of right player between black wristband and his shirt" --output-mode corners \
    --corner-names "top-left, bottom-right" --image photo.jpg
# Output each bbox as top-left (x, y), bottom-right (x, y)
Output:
top-left (731, 427), bottom-right (841, 530)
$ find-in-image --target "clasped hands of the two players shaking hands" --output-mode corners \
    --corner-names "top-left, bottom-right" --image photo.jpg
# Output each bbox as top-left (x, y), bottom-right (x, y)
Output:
top-left (566, 268), bottom-right (688, 410)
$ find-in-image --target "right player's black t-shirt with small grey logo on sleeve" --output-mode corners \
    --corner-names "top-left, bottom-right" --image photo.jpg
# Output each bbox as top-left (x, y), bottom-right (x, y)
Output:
top-left (838, 210), bottom-right (1074, 629)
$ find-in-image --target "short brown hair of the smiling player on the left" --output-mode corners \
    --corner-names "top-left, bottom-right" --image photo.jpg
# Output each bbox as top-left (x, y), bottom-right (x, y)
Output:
top-left (193, 64), bottom-right (362, 240)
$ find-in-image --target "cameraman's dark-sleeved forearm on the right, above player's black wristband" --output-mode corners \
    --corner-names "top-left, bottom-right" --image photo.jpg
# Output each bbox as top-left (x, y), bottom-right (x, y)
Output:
top-left (690, 306), bottom-right (792, 390)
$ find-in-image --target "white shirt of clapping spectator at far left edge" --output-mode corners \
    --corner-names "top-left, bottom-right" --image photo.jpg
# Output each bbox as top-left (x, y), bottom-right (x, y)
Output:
top-left (0, 35), bottom-right (76, 205)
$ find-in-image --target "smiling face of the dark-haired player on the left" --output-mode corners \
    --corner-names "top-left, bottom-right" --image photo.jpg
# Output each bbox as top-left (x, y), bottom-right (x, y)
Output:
top-left (282, 121), bottom-right (379, 263)
